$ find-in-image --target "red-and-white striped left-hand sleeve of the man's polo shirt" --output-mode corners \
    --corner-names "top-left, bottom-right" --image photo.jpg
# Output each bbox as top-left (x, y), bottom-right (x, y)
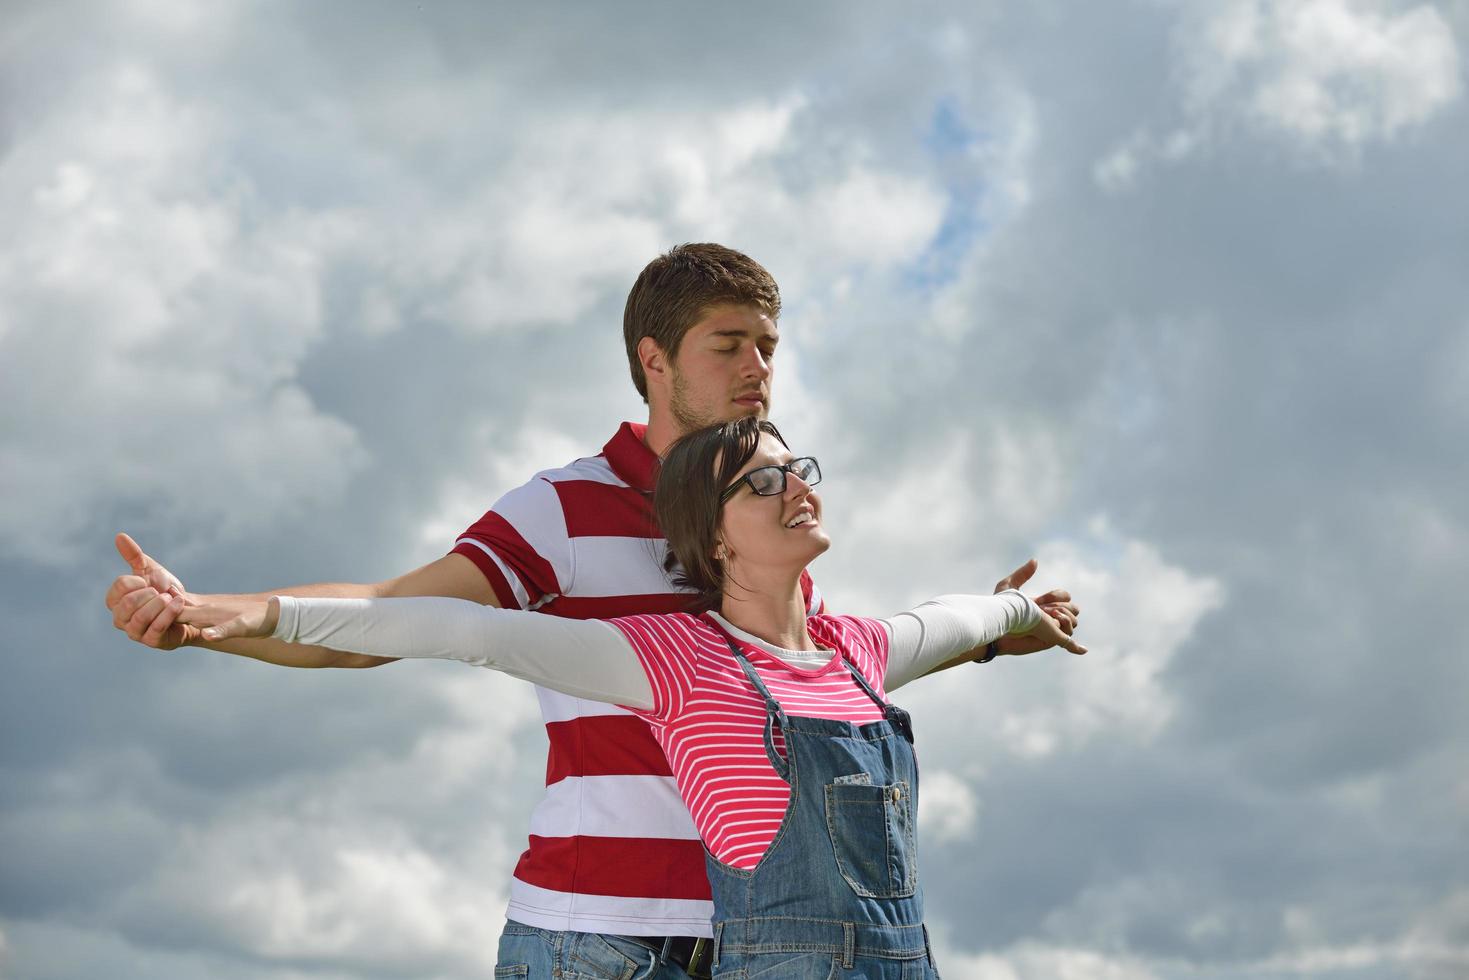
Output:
top-left (452, 476), bottom-right (571, 610)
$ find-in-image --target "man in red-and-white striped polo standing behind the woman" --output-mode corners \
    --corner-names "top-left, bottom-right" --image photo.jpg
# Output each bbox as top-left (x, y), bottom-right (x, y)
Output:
top-left (107, 244), bottom-right (1077, 980)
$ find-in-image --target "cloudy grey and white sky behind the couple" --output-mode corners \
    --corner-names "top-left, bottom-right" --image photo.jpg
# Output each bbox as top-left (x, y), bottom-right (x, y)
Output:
top-left (0, 0), bottom-right (1469, 980)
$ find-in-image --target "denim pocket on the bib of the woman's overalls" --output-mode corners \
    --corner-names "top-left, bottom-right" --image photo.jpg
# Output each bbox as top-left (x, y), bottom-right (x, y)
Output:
top-left (826, 782), bottom-right (918, 898)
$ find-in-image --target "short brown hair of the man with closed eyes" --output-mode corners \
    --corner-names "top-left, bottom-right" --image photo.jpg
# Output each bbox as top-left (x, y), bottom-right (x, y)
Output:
top-left (623, 242), bottom-right (780, 401)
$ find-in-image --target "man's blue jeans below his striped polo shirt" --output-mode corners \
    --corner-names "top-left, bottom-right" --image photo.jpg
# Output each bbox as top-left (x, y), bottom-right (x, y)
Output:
top-left (495, 923), bottom-right (689, 980)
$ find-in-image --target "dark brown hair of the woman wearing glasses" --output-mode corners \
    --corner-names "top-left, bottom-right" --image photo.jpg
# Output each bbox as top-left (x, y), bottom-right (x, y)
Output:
top-left (652, 416), bottom-right (786, 613)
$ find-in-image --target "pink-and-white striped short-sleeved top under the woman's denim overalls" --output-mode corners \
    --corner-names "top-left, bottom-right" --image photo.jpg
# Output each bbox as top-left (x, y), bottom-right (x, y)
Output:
top-left (613, 614), bottom-right (889, 870)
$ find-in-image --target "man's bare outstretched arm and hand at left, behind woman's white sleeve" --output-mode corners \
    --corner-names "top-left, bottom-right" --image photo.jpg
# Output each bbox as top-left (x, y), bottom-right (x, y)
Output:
top-left (106, 535), bottom-right (499, 667)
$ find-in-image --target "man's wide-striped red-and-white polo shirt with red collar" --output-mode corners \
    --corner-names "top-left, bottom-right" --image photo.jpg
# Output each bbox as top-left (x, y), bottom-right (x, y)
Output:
top-left (454, 422), bottom-right (821, 936)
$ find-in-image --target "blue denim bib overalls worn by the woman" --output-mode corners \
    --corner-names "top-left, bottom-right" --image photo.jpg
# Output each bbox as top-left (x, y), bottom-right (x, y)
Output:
top-left (705, 636), bottom-right (939, 980)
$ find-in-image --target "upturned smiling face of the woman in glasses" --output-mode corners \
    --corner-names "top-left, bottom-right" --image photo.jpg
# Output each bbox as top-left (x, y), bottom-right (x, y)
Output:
top-left (718, 432), bottom-right (831, 577)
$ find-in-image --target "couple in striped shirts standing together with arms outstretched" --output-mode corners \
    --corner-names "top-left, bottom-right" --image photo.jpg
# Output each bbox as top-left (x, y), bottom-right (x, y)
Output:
top-left (107, 245), bottom-right (1084, 980)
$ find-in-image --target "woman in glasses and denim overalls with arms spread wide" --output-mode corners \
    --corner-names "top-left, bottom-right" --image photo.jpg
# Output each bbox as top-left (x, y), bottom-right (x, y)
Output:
top-left (179, 419), bottom-right (1086, 980)
